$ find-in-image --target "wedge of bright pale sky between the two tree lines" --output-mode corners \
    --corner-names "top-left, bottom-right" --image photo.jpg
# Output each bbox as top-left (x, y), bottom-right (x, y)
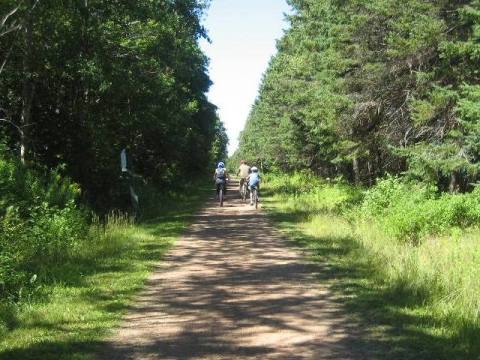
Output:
top-left (200, 0), bottom-right (289, 155)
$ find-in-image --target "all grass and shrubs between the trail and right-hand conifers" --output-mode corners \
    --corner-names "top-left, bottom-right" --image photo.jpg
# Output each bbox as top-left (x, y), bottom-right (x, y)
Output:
top-left (264, 174), bottom-right (480, 359)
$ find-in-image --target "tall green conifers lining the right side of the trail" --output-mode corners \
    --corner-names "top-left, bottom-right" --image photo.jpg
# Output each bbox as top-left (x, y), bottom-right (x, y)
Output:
top-left (235, 0), bottom-right (480, 192)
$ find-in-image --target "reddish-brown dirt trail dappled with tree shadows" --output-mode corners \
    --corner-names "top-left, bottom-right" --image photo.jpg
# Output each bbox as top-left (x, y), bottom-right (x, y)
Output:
top-left (101, 181), bottom-right (363, 359)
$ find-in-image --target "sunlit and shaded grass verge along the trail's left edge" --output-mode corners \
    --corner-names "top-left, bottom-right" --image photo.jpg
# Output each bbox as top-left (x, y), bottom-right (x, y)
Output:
top-left (0, 187), bottom-right (210, 359)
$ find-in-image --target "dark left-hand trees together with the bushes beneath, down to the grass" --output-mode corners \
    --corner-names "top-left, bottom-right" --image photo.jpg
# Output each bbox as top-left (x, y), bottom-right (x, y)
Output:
top-left (0, 0), bottom-right (228, 306)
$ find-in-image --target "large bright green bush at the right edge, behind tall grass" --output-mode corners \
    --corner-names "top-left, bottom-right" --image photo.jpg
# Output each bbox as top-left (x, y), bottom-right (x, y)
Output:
top-left (354, 177), bottom-right (480, 242)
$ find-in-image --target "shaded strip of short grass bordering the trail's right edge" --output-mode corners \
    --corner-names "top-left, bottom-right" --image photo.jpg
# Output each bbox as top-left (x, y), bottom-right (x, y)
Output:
top-left (269, 210), bottom-right (480, 360)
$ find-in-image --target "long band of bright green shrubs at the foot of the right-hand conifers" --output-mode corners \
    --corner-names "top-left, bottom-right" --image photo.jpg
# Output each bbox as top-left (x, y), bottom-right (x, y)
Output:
top-left (265, 172), bottom-right (480, 244)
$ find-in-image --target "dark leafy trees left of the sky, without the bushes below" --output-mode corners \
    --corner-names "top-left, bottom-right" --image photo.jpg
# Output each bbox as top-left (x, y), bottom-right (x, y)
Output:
top-left (0, 0), bottom-right (227, 207)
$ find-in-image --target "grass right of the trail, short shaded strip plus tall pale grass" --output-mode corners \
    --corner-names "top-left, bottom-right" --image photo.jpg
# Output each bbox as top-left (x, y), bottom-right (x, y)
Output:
top-left (263, 182), bottom-right (480, 360)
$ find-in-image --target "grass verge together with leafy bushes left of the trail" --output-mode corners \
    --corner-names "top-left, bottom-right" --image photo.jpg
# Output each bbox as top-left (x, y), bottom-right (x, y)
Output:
top-left (0, 154), bottom-right (210, 359)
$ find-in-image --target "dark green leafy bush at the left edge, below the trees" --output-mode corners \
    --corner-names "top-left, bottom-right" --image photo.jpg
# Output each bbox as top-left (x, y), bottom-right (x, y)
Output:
top-left (0, 157), bottom-right (88, 301)
